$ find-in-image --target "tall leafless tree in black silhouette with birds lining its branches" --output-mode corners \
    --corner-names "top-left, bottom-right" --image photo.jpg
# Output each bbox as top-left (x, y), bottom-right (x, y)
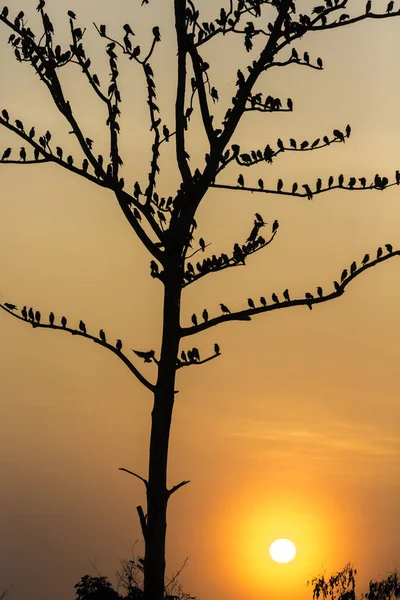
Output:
top-left (0, 0), bottom-right (400, 600)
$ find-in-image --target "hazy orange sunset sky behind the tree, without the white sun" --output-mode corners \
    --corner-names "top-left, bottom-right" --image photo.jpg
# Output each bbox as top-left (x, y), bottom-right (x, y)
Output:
top-left (0, 0), bottom-right (400, 600)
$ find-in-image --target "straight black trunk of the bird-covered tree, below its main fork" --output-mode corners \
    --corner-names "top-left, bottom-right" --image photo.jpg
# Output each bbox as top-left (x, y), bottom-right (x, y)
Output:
top-left (144, 261), bottom-right (181, 600)
